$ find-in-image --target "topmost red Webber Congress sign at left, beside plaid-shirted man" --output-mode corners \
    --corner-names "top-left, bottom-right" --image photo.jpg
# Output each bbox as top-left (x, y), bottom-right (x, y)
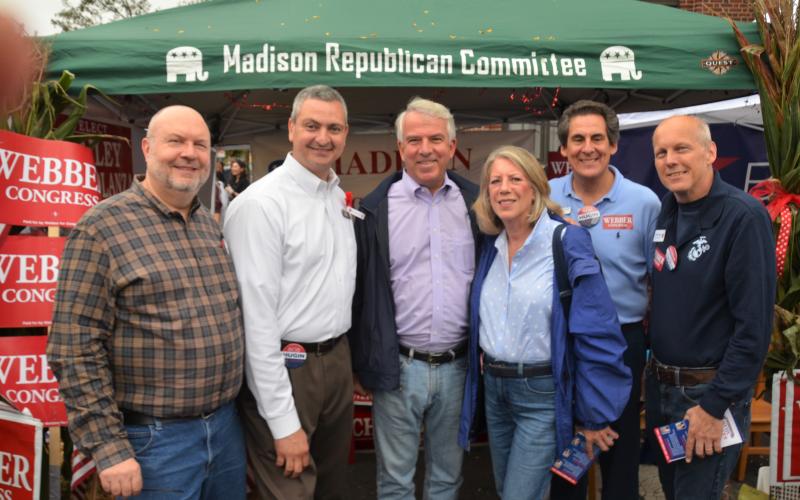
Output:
top-left (0, 130), bottom-right (100, 227)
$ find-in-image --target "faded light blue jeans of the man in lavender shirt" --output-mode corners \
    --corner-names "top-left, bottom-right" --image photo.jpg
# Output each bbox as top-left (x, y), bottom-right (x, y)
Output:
top-left (372, 355), bottom-right (466, 500)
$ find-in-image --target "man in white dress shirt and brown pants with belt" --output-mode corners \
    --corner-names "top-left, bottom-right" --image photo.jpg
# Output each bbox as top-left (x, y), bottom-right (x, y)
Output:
top-left (224, 85), bottom-right (356, 499)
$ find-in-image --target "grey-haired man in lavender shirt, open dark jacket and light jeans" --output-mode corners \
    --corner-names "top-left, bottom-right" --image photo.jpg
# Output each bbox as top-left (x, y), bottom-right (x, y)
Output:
top-left (349, 98), bottom-right (478, 499)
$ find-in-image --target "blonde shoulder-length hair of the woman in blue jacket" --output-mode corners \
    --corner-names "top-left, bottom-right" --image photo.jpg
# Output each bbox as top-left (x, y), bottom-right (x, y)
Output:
top-left (472, 146), bottom-right (561, 234)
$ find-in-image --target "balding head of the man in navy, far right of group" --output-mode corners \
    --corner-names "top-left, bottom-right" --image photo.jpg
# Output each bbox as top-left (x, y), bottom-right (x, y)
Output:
top-left (653, 115), bottom-right (717, 203)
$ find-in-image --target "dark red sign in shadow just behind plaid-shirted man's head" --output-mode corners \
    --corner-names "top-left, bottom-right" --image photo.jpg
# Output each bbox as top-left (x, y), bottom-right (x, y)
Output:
top-left (73, 118), bottom-right (133, 199)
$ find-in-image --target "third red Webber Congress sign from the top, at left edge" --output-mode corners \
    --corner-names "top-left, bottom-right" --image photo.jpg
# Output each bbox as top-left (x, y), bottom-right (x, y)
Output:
top-left (0, 335), bottom-right (67, 426)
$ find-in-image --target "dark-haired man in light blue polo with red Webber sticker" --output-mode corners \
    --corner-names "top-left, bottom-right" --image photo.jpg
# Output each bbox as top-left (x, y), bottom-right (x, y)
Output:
top-left (550, 100), bottom-right (661, 500)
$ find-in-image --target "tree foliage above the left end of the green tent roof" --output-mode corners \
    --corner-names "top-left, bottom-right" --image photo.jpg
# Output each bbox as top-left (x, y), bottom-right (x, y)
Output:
top-left (50, 0), bottom-right (151, 31)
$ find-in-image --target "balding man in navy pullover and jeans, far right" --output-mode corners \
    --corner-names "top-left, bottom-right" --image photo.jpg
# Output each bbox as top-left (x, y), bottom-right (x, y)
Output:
top-left (647, 116), bottom-right (776, 499)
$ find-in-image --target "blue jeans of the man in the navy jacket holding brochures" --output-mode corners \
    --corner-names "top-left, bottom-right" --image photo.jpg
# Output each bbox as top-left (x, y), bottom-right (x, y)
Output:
top-left (645, 373), bottom-right (753, 500)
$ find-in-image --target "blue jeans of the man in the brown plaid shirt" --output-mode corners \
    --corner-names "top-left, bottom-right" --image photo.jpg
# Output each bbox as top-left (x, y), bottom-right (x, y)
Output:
top-left (125, 402), bottom-right (246, 500)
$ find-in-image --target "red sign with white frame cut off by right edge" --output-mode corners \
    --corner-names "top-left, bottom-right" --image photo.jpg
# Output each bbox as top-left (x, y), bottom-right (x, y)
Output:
top-left (769, 370), bottom-right (800, 484)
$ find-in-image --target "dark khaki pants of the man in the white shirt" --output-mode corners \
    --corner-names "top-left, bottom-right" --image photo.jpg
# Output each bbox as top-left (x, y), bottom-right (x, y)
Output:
top-left (239, 337), bottom-right (353, 500)
